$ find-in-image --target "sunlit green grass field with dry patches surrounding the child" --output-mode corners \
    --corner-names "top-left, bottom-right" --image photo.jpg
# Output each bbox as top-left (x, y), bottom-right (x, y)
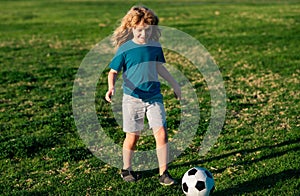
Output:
top-left (0, 0), bottom-right (300, 195)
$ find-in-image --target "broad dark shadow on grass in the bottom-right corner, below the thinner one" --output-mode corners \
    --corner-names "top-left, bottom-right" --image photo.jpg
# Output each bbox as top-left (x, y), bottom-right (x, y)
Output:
top-left (213, 169), bottom-right (300, 196)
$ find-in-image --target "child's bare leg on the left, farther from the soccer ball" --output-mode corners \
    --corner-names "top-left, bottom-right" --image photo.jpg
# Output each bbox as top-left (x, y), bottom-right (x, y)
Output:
top-left (123, 132), bottom-right (140, 170)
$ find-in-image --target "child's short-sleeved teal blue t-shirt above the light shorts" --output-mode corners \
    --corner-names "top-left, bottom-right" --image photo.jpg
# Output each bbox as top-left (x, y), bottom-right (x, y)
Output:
top-left (109, 40), bottom-right (166, 100)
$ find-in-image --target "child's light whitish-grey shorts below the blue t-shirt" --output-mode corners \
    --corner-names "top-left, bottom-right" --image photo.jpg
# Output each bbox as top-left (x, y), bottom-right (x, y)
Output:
top-left (122, 94), bottom-right (166, 133)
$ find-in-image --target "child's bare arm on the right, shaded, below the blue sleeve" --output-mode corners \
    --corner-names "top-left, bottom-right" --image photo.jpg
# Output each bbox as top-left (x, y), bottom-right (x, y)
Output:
top-left (156, 63), bottom-right (181, 100)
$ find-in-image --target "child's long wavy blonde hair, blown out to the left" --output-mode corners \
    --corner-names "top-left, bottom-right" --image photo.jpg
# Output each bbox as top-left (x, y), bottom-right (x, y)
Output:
top-left (111, 6), bottom-right (161, 48)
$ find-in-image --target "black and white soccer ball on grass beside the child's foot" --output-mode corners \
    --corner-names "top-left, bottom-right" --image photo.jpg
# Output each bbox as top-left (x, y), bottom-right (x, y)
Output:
top-left (182, 167), bottom-right (215, 196)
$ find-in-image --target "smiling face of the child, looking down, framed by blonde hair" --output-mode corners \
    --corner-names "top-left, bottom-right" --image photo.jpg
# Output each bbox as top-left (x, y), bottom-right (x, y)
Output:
top-left (132, 24), bottom-right (152, 44)
